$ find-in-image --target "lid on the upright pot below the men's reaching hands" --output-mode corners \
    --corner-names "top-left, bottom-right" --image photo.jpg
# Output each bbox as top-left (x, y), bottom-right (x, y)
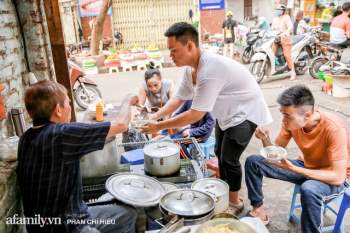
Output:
top-left (143, 141), bottom-right (179, 158)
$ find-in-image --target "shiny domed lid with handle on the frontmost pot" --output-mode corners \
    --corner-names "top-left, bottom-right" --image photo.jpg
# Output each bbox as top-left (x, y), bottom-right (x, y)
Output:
top-left (159, 189), bottom-right (215, 216)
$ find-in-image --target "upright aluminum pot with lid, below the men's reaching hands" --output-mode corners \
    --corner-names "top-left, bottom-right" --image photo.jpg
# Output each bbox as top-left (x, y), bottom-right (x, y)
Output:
top-left (143, 141), bottom-right (180, 176)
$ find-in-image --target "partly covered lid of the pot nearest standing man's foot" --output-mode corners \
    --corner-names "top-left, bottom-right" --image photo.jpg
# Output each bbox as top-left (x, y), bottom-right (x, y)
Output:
top-left (191, 178), bottom-right (229, 197)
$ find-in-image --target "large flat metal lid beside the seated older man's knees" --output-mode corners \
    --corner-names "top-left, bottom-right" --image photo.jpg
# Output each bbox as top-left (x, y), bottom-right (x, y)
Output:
top-left (106, 173), bottom-right (165, 207)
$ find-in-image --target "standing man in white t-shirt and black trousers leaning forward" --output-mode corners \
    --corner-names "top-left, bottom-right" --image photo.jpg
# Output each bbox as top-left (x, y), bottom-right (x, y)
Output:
top-left (143, 22), bottom-right (272, 214)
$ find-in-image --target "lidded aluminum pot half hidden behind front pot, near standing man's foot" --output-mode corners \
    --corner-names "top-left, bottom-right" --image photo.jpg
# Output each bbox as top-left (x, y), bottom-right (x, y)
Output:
top-left (191, 178), bottom-right (230, 213)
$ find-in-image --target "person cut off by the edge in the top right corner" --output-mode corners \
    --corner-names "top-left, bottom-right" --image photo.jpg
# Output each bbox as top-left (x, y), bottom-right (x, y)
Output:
top-left (330, 2), bottom-right (350, 46)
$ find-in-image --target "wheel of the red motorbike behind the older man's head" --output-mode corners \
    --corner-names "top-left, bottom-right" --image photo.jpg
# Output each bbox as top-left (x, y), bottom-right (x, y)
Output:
top-left (74, 84), bottom-right (102, 110)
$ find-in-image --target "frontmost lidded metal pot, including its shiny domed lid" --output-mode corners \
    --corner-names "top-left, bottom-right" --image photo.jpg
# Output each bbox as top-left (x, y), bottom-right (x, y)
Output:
top-left (159, 189), bottom-right (215, 226)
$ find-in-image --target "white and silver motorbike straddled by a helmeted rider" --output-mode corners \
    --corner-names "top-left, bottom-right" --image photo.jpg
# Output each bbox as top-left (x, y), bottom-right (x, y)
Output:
top-left (249, 31), bottom-right (317, 83)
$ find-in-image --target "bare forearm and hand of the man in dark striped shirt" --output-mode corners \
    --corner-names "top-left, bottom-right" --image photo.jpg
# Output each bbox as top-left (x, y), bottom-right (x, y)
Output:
top-left (107, 95), bottom-right (138, 138)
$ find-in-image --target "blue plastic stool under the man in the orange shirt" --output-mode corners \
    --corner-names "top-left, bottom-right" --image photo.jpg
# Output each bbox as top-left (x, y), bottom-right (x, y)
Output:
top-left (288, 185), bottom-right (350, 233)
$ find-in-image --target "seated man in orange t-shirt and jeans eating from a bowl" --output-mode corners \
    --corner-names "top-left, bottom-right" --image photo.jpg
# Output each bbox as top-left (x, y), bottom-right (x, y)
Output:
top-left (245, 85), bottom-right (350, 233)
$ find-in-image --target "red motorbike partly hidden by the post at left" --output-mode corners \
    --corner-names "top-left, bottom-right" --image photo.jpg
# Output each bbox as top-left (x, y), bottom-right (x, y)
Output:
top-left (68, 60), bottom-right (102, 110)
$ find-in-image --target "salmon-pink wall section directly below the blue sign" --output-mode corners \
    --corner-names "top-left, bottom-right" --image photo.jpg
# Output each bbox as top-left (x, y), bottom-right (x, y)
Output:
top-left (200, 10), bottom-right (225, 38)
